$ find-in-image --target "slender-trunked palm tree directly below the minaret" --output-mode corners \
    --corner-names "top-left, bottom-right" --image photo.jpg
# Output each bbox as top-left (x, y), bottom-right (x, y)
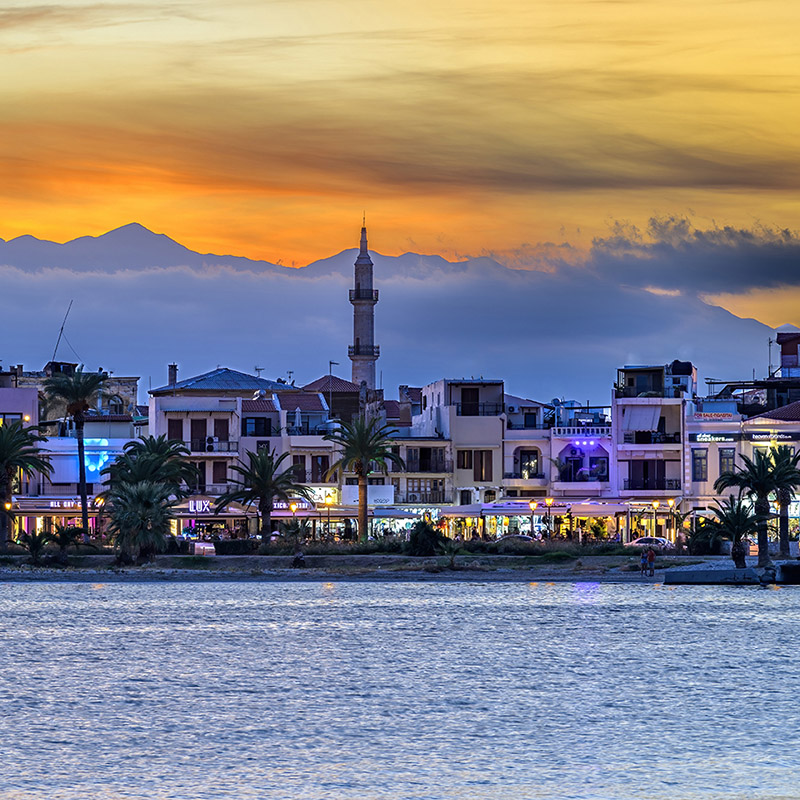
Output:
top-left (322, 415), bottom-right (405, 540)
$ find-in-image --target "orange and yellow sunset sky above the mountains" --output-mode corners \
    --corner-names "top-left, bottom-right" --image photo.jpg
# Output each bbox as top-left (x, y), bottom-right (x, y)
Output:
top-left (0, 0), bottom-right (800, 324)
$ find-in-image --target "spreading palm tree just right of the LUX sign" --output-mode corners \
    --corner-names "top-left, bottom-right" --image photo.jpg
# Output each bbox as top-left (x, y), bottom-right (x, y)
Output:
top-left (216, 449), bottom-right (311, 541)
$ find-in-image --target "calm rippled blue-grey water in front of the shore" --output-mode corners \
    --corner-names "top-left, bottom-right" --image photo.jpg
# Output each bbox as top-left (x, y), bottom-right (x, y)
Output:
top-left (0, 583), bottom-right (800, 800)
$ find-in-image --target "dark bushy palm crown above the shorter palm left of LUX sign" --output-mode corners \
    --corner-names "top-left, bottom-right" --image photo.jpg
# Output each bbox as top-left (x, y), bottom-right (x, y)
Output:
top-left (103, 435), bottom-right (198, 498)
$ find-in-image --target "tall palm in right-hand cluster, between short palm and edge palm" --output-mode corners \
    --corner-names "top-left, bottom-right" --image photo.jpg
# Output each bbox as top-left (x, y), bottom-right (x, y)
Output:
top-left (714, 448), bottom-right (800, 567)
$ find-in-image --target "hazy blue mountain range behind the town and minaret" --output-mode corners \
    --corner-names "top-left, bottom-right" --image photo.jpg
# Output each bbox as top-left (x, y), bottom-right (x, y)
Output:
top-left (0, 223), bottom-right (772, 402)
